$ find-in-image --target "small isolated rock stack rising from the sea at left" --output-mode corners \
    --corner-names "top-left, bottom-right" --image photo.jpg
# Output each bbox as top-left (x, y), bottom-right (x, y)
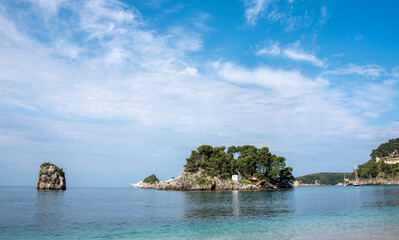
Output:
top-left (36, 162), bottom-right (66, 190)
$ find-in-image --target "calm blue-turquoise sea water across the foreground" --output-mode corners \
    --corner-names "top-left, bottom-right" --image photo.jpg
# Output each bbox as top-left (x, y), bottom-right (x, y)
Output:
top-left (0, 186), bottom-right (399, 239)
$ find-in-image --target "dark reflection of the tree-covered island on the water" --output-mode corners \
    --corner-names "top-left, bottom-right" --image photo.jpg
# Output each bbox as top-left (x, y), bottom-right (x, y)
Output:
top-left (184, 190), bottom-right (295, 218)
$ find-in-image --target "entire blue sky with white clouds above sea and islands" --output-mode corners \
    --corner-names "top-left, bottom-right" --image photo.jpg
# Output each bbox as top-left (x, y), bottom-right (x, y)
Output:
top-left (0, 0), bottom-right (399, 187)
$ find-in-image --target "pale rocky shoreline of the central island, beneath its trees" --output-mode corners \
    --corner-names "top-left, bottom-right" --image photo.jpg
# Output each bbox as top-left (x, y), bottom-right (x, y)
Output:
top-left (141, 171), bottom-right (277, 191)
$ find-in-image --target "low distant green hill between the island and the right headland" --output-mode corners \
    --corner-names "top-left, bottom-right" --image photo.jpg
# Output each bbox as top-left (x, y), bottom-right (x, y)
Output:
top-left (295, 172), bottom-right (353, 185)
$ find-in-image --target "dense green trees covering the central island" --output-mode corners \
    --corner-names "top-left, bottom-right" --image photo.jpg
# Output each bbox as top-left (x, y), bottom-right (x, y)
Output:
top-left (184, 145), bottom-right (294, 187)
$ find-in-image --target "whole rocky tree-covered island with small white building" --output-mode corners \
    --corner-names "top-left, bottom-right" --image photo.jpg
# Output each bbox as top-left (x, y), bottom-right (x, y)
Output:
top-left (140, 145), bottom-right (294, 191)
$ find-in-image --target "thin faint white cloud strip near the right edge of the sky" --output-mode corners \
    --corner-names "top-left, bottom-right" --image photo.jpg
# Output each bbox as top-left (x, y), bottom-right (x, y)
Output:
top-left (325, 63), bottom-right (385, 77)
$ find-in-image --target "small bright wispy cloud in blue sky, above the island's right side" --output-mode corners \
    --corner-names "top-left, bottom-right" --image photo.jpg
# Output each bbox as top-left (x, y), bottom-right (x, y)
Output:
top-left (256, 42), bottom-right (325, 67)
